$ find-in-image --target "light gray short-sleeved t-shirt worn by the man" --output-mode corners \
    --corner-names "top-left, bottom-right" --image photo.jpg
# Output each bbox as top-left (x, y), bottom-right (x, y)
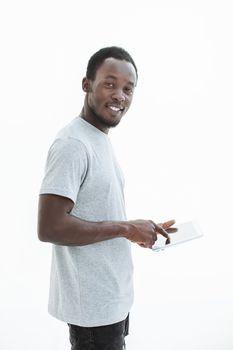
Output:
top-left (40, 117), bottom-right (133, 327)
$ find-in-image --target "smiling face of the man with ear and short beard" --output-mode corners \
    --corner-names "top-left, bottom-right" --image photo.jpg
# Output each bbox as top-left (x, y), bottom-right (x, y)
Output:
top-left (83, 58), bottom-right (137, 132)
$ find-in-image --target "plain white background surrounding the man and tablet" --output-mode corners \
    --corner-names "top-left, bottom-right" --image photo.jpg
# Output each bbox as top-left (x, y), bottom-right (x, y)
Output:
top-left (0, 0), bottom-right (233, 350)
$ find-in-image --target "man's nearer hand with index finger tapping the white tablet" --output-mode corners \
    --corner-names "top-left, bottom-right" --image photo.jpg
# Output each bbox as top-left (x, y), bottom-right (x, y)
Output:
top-left (126, 220), bottom-right (175, 248)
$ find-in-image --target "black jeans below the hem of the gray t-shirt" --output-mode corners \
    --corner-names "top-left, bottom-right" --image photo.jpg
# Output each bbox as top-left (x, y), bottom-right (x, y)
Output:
top-left (68, 315), bottom-right (129, 350)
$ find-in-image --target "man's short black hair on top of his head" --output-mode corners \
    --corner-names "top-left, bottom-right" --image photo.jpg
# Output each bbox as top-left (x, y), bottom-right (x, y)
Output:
top-left (86, 46), bottom-right (138, 80)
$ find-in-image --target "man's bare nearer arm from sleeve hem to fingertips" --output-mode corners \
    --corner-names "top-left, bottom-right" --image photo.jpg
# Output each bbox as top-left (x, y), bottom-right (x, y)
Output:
top-left (38, 194), bottom-right (169, 247)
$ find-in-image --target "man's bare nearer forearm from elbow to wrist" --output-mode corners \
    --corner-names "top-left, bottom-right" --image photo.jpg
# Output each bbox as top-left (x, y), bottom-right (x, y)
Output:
top-left (39, 214), bottom-right (128, 246)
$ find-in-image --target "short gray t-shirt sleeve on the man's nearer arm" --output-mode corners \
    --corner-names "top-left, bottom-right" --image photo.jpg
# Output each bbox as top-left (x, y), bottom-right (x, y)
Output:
top-left (40, 138), bottom-right (88, 203)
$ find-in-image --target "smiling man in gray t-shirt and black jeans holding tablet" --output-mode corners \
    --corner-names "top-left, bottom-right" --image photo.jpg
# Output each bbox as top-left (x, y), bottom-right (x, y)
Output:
top-left (38, 47), bottom-right (174, 350)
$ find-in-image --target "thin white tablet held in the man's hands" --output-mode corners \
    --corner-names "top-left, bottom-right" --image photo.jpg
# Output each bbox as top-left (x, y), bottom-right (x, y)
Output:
top-left (152, 221), bottom-right (203, 252)
